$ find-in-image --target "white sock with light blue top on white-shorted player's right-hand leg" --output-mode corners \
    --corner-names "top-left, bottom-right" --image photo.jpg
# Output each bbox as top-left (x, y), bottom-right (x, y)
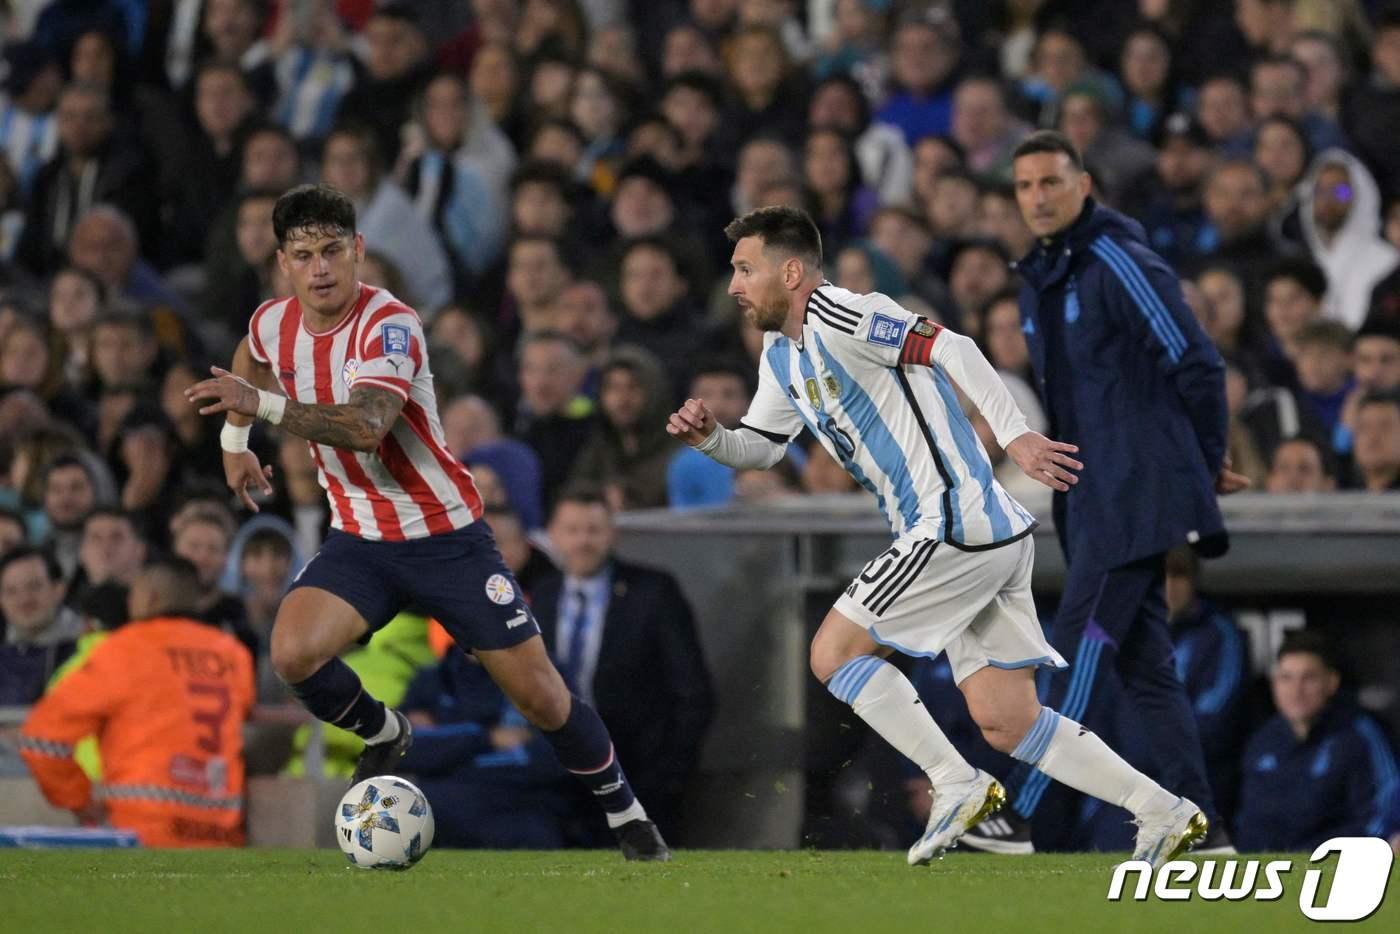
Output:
top-left (1011, 707), bottom-right (1176, 816)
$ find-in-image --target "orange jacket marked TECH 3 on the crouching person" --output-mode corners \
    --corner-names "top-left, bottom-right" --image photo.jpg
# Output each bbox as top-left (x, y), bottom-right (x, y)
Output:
top-left (20, 618), bottom-right (253, 847)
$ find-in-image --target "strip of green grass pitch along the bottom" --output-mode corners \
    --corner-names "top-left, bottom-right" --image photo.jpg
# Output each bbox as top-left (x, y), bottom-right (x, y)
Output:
top-left (0, 850), bottom-right (1400, 934)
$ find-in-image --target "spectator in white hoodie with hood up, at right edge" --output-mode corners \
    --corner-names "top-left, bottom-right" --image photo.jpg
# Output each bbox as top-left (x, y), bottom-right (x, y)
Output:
top-left (1301, 150), bottom-right (1400, 329)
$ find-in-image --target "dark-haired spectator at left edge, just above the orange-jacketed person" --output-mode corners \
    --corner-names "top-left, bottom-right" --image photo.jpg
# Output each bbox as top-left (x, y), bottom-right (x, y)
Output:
top-left (0, 546), bottom-right (81, 706)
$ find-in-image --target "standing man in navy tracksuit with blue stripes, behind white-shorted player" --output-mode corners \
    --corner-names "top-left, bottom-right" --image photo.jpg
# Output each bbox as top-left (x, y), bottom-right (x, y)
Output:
top-left (963, 132), bottom-right (1247, 853)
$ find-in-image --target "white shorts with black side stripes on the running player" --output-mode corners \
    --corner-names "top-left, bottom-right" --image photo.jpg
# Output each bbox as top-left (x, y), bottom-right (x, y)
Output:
top-left (836, 534), bottom-right (1068, 683)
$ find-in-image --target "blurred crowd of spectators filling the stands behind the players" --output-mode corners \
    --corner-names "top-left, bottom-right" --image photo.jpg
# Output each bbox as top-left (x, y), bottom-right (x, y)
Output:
top-left (0, 0), bottom-right (1400, 849)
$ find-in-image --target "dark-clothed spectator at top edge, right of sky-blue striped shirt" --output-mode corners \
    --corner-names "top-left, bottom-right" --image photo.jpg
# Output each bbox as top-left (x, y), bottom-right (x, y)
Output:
top-left (332, 3), bottom-right (431, 165)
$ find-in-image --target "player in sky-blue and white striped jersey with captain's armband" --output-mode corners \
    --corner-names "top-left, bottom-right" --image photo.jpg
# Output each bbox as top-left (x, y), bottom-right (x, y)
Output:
top-left (666, 207), bottom-right (1205, 865)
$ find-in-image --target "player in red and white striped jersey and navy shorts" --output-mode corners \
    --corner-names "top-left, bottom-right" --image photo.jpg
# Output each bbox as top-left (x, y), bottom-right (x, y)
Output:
top-left (188, 185), bottom-right (671, 860)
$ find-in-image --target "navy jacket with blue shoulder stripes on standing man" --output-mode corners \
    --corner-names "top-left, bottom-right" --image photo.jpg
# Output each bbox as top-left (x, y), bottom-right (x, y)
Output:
top-left (1016, 199), bottom-right (1228, 570)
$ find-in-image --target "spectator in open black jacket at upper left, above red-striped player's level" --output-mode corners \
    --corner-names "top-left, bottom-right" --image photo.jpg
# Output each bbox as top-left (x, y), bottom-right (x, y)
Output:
top-left (17, 84), bottom-right (160, 277)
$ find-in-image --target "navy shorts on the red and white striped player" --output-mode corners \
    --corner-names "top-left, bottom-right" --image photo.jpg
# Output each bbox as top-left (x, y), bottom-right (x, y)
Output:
top-left (291, 521), bottom-right (539, 650)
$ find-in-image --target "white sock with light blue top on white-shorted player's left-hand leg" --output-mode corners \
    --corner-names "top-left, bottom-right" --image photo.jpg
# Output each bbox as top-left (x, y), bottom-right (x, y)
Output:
top-left (826, 655), bottom-right (977, 787)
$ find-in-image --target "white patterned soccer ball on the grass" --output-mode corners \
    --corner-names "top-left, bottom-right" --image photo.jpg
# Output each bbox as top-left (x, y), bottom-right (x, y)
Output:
top-left (336, 776), bottom-right (433, 870)
